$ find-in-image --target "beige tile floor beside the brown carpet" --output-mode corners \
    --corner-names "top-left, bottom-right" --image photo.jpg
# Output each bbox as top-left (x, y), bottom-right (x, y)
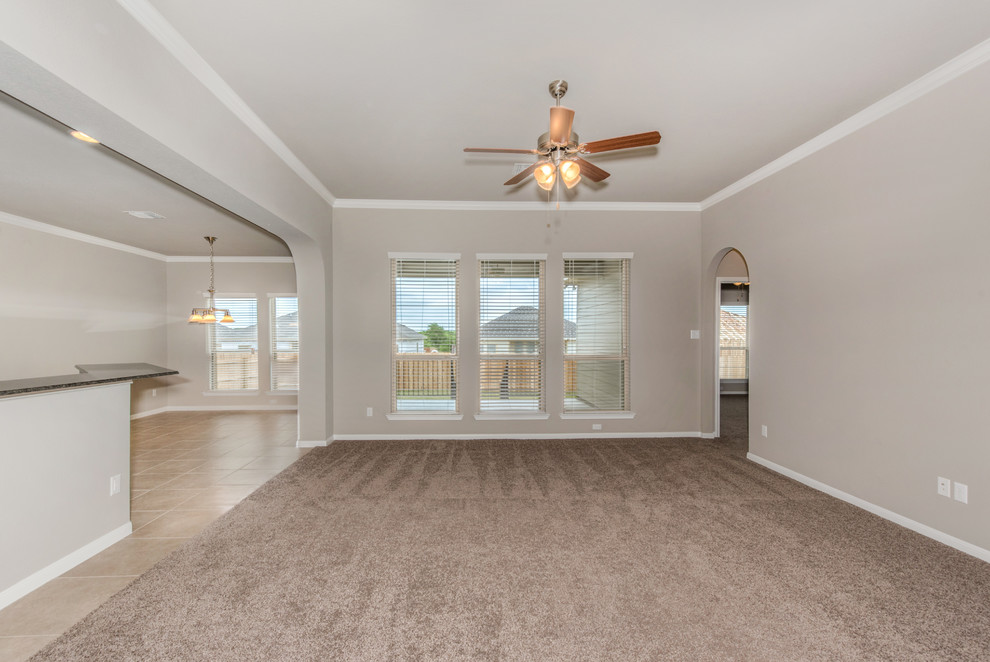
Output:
top-left (0, 412), bottom-right (308, 662)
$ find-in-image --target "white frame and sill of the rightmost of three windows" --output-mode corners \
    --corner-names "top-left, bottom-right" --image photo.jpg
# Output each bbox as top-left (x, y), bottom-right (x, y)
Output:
top-left (560, 252), bottom-right (636, 419)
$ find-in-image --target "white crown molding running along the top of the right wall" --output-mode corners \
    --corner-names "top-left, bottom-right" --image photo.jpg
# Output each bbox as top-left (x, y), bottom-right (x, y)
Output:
top-left (699, 39), bottom-right (990, 211)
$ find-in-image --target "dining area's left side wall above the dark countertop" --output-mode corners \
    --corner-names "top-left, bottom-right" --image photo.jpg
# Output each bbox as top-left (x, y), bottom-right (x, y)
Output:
top-left (0, 222), bottom-right (166, 413)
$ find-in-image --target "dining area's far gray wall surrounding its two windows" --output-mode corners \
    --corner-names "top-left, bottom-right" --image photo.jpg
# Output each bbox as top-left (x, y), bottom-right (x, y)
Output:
top-left (167, 262), bottom-right (296, 408)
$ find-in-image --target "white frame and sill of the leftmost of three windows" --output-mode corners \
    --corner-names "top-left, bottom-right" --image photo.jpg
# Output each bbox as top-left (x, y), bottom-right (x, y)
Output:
top-left (385, 252), bottom-right (464, 421)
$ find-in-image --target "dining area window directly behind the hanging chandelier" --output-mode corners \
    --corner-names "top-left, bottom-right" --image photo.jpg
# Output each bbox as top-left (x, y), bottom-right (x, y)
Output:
top-left (206, 297), bottom-right (258, 391)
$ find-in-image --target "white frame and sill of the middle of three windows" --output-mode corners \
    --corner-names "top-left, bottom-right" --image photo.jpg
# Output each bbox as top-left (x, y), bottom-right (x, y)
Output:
top-left (474, 253), bottom-right (550, 421)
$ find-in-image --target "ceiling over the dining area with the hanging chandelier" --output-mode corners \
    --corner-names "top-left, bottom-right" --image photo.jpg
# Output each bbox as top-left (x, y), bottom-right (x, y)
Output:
top-left (0, 94), bottom-right (289, 256)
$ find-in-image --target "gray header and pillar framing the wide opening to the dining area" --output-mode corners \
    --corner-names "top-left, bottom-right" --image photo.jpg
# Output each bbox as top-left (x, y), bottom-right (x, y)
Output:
top-left (0, 40), bottom-right (333, 446)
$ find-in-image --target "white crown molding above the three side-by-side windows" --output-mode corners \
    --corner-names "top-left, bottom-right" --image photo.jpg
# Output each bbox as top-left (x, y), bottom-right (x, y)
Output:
top-left (333, 198), bottom-right (701, 212)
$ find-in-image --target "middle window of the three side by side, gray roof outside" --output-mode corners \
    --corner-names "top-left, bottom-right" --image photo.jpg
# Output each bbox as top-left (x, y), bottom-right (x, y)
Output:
top-left (478, 256), bottom-right (546, 413)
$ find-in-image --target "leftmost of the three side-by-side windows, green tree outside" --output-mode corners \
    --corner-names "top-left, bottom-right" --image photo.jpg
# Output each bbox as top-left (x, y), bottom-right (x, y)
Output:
top-left (392, 255), bottom-right (459, 414)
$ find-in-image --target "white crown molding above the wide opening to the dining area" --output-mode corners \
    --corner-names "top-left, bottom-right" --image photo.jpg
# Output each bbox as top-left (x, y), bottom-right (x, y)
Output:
top-left (117, 0), bottom-right (336, 206)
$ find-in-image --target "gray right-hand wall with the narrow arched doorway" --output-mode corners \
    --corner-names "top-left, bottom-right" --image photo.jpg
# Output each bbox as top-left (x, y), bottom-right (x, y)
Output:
top-left (702, 65), bottom-right (990, 549)
